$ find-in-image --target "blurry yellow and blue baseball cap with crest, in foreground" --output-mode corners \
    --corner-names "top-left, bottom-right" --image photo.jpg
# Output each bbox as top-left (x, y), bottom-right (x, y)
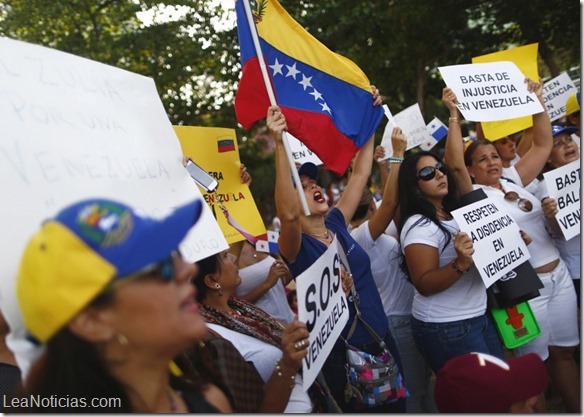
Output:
top-left (16, 199), bottom-right (202, 343)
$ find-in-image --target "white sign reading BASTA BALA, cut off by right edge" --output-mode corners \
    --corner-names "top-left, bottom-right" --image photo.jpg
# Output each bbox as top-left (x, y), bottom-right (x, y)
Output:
top-left (543, 159), bottom-right (580, 240)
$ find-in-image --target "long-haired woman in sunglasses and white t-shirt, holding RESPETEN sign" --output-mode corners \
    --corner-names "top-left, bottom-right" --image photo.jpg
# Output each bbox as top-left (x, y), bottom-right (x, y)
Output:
top-left (398, 148), bottom-right (504, 372)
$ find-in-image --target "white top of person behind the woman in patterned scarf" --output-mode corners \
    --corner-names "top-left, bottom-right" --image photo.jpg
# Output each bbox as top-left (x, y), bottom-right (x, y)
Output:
top-left (235, 256), bottom-right (294, 323)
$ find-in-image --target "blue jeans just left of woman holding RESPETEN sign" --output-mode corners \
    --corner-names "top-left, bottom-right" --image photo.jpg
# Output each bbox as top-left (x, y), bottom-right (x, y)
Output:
top-left (387, 314), bottom-right (438, 414)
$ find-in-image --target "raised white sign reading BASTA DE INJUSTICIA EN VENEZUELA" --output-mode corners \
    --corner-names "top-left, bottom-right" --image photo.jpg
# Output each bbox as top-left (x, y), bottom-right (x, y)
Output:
top-left (438, 61), bottom-right (543, 122)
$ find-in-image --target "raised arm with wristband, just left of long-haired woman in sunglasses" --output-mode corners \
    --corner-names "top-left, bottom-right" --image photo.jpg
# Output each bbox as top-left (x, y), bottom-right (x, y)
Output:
top-left (369, 127), bottom-right (407, 240)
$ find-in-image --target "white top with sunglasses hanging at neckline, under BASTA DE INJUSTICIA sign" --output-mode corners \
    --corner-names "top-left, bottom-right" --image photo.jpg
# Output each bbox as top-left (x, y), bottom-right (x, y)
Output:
top-left (474, 179), bottom-right (560, 269)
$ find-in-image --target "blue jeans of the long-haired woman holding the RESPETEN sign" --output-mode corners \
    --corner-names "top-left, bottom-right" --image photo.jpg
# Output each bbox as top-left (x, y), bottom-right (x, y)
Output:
top-left (406, 314), bottom-right (505, 372)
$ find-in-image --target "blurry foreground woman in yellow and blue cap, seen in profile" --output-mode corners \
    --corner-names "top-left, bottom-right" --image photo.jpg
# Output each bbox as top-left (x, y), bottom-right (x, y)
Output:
top-left (16, 199), bottom-right (231, 413)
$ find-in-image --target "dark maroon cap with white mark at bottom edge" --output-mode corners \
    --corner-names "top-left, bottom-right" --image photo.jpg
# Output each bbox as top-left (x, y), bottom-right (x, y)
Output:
top-left (435, 353), bottom-right (548, 413)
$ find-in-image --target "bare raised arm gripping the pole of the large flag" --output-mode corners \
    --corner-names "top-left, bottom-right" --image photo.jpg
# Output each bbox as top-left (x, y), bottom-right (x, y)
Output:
top-left (266, 106), bottom-right (302, 262)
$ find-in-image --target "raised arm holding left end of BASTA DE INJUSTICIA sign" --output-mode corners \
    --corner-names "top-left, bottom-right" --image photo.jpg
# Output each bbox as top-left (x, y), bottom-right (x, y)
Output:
top-left (442, 87), bottom-right (473, 196)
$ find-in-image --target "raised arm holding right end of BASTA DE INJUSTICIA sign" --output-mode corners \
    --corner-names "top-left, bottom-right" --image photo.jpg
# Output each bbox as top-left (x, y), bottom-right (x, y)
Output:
top-left (515, 78), bottom-right (554, 186)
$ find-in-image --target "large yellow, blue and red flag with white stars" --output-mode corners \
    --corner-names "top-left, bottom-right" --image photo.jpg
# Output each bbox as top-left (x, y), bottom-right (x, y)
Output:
top-left (235, 0), bottom-right (383, 175)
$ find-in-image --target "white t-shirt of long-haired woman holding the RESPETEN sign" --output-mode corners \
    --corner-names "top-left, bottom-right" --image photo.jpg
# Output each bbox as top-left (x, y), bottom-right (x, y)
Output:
top-left (401, 214), bottom-right (487, 323)
